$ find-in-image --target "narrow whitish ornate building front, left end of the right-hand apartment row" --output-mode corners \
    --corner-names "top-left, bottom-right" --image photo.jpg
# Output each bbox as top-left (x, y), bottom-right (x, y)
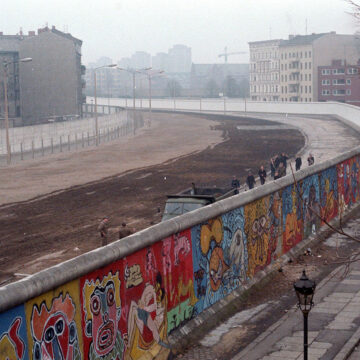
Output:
top-left (249, 40), bottom-right (281, 101)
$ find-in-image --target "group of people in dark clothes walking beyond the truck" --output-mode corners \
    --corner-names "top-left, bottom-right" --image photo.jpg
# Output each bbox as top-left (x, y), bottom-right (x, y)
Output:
top-left (231, 152), bottom-right (315, 193)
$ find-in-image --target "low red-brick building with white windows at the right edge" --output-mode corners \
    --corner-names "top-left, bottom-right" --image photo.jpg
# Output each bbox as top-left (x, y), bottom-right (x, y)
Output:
top-left (318, 60), bottom-right (360, 106)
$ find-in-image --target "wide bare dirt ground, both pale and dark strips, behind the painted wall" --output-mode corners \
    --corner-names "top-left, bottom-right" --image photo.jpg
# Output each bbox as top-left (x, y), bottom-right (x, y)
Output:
top-left (0, 114), bottom-right (304, 284)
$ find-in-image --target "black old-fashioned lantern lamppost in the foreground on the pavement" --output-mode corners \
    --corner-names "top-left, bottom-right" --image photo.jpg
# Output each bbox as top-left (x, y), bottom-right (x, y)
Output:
top-left (294, 270), bottom-right (316, 360)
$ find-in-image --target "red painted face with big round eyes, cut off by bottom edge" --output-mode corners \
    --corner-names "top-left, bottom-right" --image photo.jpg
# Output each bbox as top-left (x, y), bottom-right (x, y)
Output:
top-left (33, 313), bottom-right (76, 360)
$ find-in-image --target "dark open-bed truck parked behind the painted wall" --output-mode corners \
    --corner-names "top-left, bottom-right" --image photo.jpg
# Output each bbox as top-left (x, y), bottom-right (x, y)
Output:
top-left (161, 186), bottom-right (238, 221)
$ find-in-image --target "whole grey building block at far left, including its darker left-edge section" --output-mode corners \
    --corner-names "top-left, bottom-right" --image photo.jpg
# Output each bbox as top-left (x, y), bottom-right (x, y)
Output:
top-left (0, 27), bottom-right (85, 125)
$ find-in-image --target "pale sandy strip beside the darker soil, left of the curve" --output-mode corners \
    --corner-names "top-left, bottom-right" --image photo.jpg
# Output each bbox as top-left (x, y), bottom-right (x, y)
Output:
top-left (0, 114), bottom-right (222, 204)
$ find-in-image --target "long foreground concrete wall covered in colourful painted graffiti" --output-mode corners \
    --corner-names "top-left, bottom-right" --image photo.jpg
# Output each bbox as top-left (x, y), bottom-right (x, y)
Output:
top-left (0, 148), bottom-right (360, 360)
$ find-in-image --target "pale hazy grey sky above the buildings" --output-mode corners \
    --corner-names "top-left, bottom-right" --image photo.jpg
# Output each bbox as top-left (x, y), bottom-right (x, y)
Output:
top-left (0, 0), bottom-right (358, 64)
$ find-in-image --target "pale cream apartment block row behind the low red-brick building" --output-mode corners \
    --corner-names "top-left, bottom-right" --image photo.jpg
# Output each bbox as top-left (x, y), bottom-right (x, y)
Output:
top-left (249, 31), bottom-right (360, 102)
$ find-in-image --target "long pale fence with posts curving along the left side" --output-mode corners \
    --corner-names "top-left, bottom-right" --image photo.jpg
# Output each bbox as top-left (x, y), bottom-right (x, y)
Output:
top-left (0, 106), bottom-right (144, 166)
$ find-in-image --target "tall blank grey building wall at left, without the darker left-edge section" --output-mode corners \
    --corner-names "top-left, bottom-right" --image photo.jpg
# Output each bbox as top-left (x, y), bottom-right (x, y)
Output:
top-left (19, 26), bottom-right (85, 124)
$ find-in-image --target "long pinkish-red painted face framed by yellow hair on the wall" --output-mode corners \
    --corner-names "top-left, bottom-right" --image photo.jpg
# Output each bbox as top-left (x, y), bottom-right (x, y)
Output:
top-left (90, 281), bottom-right (117, 356)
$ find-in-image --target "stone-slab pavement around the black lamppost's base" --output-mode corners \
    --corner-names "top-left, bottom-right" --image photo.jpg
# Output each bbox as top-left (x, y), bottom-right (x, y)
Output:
top-left (233, 219), bottom-right (360, 360)
